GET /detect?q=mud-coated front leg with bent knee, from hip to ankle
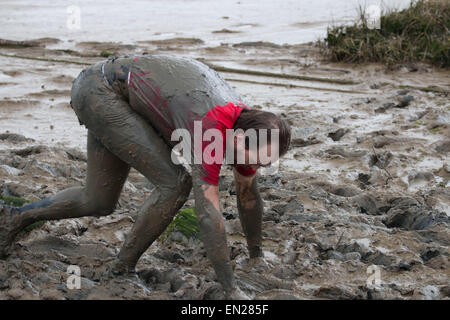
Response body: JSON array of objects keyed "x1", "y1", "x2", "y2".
[{"x1": 67, "y1": 64, "x2": 192, "y2": 271}]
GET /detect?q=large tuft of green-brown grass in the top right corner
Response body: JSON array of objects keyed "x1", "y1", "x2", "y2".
[{"x1": 319, "y1": 0, "x2": 450, "y2": 68}]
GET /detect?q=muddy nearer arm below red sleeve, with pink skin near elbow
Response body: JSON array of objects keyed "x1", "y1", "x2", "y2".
[{"x1": 192, "y1": 168, "x2": 235, "y2": 294}]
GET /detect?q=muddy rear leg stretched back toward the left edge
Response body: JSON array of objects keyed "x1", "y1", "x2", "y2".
[{"x1": 0, "y1": 132, "x2": 130, "y2": 254}]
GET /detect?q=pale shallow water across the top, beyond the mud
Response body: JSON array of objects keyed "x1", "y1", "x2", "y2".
[{"x1": 0, "y1": 0, "x2": 410, "y2": 46}]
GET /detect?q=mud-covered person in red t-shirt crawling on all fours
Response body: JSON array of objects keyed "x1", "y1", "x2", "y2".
[{"x1": 0, "y1": 55, "x2": 290, "y2": 299}]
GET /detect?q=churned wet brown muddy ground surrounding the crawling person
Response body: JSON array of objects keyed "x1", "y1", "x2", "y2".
[{"x1": 0, "y1": 37, "x2": 450, "y2": 299}]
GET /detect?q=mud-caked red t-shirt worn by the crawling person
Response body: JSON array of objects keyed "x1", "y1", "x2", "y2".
[{"x1": 106, "y1": 55, "x2": 255, "y2": 185}]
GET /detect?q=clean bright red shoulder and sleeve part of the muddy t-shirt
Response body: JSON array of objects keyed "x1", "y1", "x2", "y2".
[{"x1": 201, "y1": 102, "x2": 256, "y2": 186}]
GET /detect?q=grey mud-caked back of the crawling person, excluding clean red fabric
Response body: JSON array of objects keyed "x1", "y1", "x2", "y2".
[{"x1": 103, "y1": 55, "x2": 243, "y2": 145}]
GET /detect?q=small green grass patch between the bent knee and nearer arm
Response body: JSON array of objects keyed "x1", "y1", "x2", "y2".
[{"x1": 161, "y1": 208, "x2": 200, "y2": 242}]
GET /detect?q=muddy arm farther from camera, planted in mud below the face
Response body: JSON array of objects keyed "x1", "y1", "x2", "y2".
[{"x1": 233, "y1": 168, "x2": 264, "y2": 258}]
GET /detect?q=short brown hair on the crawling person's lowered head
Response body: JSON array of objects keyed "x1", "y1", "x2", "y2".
[{"x1": 233, "y1": 108, "x2": 291, "y2": 156}]
